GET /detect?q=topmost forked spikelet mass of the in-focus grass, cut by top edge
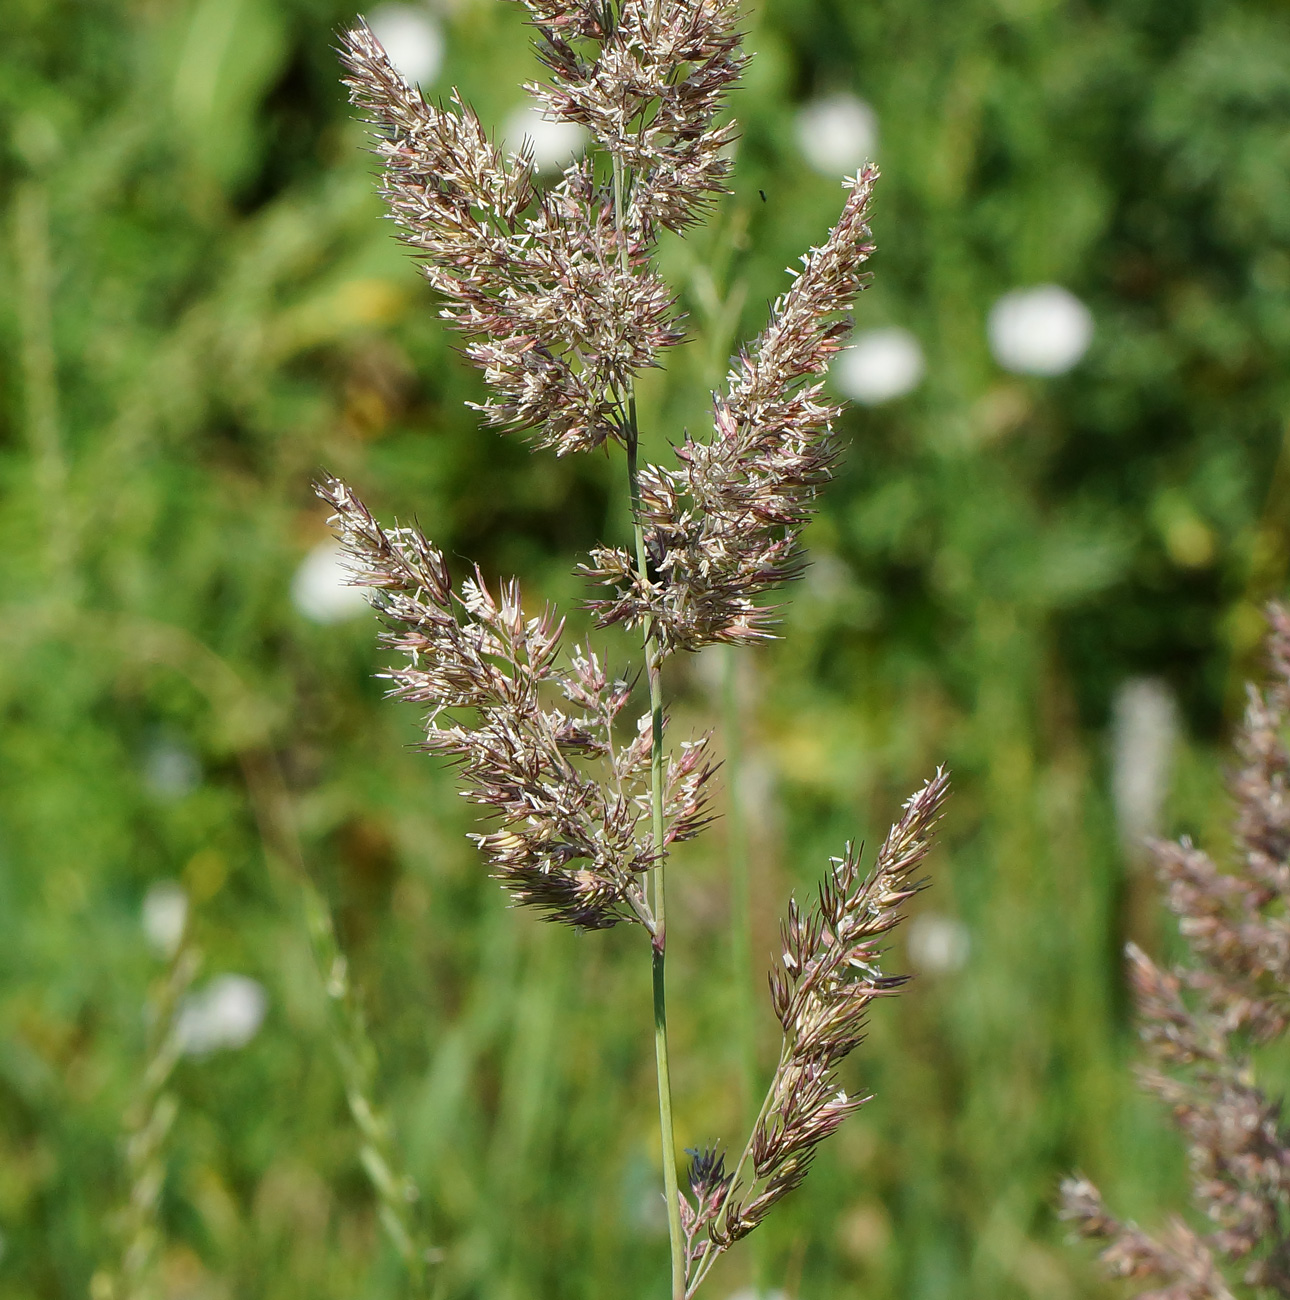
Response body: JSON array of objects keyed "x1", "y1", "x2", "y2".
[{"x1": 341, "y1": 0, "x2": 741, "y2": 455}]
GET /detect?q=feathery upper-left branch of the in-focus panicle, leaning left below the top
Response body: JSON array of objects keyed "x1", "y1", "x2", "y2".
[{"x1": 341, "y1": 22, "x2": 683, "y2": 455}]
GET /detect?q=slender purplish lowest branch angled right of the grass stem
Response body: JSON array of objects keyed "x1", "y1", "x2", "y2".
[{"x1": 684, "y1": 770, "x2": 949, "y2": 1287}]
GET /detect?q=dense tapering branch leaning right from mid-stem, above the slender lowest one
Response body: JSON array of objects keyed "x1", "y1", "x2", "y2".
[{"x1": 584, "y1": 166, "x2": 878, "y2": 650}]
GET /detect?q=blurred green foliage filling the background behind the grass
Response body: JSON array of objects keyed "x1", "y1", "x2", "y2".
[{"x1": 0, "y1": 0, "x2": 1290, "y2": 1300}]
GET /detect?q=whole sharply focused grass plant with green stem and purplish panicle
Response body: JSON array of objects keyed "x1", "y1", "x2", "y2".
[{"x1": 319, "y1": 0, "x2": 947, "y2": 1300}]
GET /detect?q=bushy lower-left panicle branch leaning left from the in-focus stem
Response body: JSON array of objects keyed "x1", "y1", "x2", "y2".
[{"x1": 317, "y1": 478, "x2": 713, "y2": 930}]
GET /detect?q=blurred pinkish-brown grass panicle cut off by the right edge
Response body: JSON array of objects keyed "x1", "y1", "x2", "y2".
[{"x1": 1062, "y1": 606, "x2": 1290, "y2": 1300}]
